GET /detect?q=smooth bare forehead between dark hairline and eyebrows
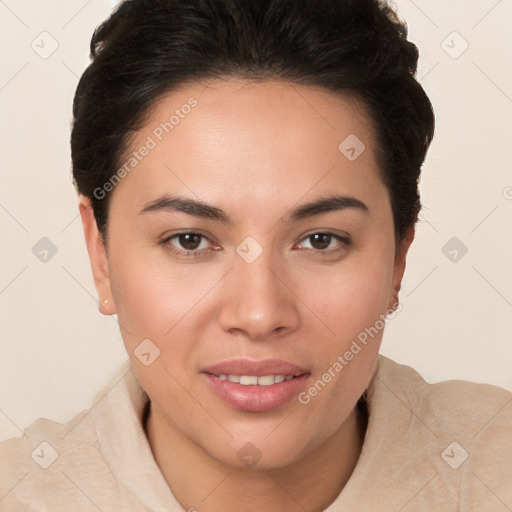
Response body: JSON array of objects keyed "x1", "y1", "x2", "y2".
[{"x1": 114, "y1": 79, "x2": 382, "y2": 212}]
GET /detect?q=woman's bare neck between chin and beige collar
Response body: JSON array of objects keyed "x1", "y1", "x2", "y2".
[{"x1": 145, "y1": 404, "x2": 367, "y2": 512}]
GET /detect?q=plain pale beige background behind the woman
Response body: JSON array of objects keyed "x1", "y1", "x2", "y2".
[{"x1": 0, "y1": 0, "x2": 512, "y2": 439}]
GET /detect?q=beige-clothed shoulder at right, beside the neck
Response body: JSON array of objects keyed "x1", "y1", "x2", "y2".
[{"x1": 363, "y1": 356, "x2": 512, "y2": 511}]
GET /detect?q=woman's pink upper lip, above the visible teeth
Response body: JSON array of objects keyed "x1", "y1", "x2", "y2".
[{"x1": 202, "y1": 359, "x2": 309, "y2": 377}]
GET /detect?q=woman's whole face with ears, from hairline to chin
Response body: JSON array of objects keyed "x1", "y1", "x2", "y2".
[{"x1": 83, "y1": 80, "x2": 408, "y2": 467}]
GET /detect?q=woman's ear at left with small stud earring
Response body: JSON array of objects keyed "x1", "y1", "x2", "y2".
[{"x1": 78, "y1": 195, "x2": 116, "y2": 315}]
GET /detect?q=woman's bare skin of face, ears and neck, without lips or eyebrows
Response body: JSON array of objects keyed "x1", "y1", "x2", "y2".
[{"x1": 80, "y1": 79, "x2": 414, "y2": 512}]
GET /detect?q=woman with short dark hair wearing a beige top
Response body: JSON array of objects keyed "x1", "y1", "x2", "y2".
[{"x1": 0, "y1": 0, "x2": 512, "y2": 512}]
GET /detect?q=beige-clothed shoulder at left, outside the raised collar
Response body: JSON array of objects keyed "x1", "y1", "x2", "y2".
[{"x1": 0, "y1": 365, "x2": 139, "y2": 512}]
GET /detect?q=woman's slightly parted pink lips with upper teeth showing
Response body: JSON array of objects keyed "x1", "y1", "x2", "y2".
[{"x1": 202, "y1": 359, "x2": 310, "y2": 412}]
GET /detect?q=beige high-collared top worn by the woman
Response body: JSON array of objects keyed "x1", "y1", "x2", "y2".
[{"x1": 0, "y1": 356, "x2": 512, "y2": 512}]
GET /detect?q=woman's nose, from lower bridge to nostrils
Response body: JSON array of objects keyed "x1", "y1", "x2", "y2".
[{"x1": 219, "y1": 255, "x2": 300, "y2": 341}]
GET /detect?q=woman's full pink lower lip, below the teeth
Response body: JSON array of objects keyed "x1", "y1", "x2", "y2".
[{"x1": 204, "y1": 373, "x2": 309, "y2": 412}]
